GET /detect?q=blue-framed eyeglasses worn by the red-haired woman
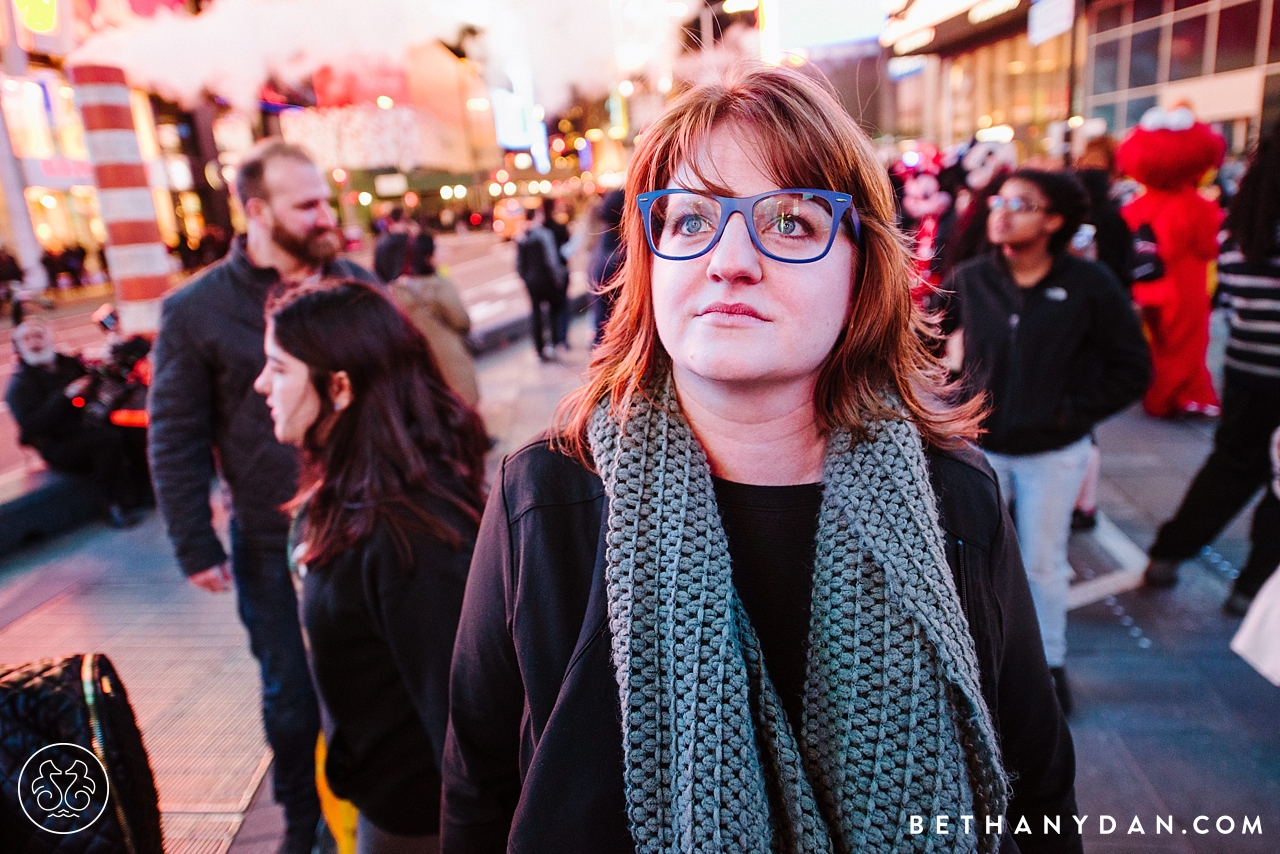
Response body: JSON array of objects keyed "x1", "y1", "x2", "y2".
[{"x1": 636, "y1": 189, "x2": 860, "y2": 264}]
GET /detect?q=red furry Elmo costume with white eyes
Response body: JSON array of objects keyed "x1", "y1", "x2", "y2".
[{"x1": 1116, "y1": 108, "x2": 1225, "y2": 417}]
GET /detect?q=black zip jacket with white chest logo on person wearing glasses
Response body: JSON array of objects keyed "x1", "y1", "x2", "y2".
[{"x1": 942, "y1": 252, "x2": 1151, "y2": 455}]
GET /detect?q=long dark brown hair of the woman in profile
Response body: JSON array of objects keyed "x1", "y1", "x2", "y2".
[{"x1": 268, "y1": 280, "x2": 488, "y2": 565}]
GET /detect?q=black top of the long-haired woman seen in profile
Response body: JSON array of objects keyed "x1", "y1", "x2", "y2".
[{"x1": 302, "y1": 498, "x2": 475, "y2": 836}]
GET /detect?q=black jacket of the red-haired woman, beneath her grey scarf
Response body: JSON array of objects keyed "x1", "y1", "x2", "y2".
[{"x1": 440, "y1": 439, "x2": 1082, "y2": 854}]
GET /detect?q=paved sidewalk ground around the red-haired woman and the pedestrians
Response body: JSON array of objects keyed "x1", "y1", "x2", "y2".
[{"x1": 0, "y1": 313, "x2": 1280, "y2": 854}]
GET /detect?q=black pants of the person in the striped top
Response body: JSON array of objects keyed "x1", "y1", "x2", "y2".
[{"x1": 1151, "y1": 373, "x2": 1280, "y2": 597}]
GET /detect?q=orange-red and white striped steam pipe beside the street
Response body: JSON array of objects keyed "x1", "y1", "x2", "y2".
[{"x1": 70, "y1": 65, "x2": 172, "y2": 335}]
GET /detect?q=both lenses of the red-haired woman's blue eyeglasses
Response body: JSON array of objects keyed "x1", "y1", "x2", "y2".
[{"x1": 649, "y1": 192, "x2": 832, "y2": 261}]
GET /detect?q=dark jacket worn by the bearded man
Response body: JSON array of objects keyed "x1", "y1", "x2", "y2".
[{"x1": 147, "y1": 237, "x2": 376, "y2": 575}]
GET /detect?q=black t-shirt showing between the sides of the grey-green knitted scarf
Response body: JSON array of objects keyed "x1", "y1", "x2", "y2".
[{"x1": 713, "y1": 478, "x2": 822, "y2": 735}]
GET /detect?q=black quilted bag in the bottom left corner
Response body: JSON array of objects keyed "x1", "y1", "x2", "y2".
[{"x1": 0, "y1": 654, "x2": 164, "y2": 854}]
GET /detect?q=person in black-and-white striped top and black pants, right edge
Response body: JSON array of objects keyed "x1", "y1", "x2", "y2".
[{"x1": 1146, "y1": 124, "x2": 1280, "y2": 617}]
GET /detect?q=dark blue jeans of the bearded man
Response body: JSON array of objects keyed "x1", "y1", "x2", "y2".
[{"x1": 232, "y1": 521, "x2": 320, "y2": 853}]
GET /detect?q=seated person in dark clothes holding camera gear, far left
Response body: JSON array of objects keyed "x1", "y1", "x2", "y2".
[{"x1": 5, "y1": 321, "x2": 146, "y2": 528}]
